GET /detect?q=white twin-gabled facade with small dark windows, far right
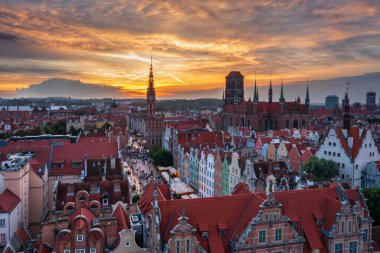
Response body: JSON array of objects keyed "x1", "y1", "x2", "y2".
[{"x1": 316, "y1": 128, "x2": 379, "y2": 187}]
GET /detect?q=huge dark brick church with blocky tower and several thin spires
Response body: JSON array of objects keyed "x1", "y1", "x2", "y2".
[{"x1": 221, "y1": 71, "x2": 310, "y2": 131}]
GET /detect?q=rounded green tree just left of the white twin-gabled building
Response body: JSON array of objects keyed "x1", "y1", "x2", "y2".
[{"x1": 304, "y1": 156, "x2": 339, "y2": 181}]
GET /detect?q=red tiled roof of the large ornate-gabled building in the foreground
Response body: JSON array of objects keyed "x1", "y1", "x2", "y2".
[{"x1": 139, "y1": 184, "x2": 364, "y2": 252}]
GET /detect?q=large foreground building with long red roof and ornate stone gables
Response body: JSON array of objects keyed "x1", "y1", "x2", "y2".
[{"x1": 139, "y1": 183, "x2": 373, "y2": 253}]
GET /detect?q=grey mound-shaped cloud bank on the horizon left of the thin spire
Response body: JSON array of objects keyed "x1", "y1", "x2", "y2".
[{"x1": 16, "y1": 78, "x2": 121, "y2": 98}]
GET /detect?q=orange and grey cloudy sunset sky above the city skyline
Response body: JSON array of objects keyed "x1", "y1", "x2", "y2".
[{"x1": 0, "y1": 0, "x2": 380, "y2": 98}]
